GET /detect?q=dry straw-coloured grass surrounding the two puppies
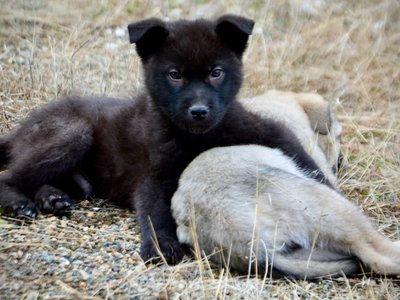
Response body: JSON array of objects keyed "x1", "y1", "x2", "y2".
[{"x1": 0, "y1": 0, "x2": 400, "y2": 299}]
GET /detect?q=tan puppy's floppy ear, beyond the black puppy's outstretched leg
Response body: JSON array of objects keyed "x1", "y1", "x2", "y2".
[{"x1": 297, "y1": 94, "x2": 333, "y2": 135}]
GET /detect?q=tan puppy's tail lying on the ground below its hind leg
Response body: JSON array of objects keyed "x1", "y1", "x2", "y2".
[{"x1": 272, "y1": 250, "x2": 360, "y2": 279}]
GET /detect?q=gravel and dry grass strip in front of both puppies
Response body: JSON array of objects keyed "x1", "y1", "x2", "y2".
[{"x1": 0, "y1": 201, "x2": 400, "y2": 300}]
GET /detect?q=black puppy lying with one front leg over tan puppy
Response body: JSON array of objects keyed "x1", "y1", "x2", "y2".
[{"x1": 0, "y1": 15, "x2": 329, "y2": 262}]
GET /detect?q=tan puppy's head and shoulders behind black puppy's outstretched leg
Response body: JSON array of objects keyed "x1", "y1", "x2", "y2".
[{"x1": 241, "y1": 90, "x2": 342, "y2": 183}]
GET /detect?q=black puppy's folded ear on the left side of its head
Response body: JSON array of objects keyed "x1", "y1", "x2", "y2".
[{"x1": 128, "y1": 18, "x2": 169, "y2": 61}]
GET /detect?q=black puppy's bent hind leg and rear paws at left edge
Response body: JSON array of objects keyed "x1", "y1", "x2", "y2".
[{"x1": 0, "y1": 116, "x2": 93, "y2": 217}]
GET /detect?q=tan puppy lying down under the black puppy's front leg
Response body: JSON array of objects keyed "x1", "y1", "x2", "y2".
[{"x1": 172, "y1": 91, "x2": 400, "y2": 278}]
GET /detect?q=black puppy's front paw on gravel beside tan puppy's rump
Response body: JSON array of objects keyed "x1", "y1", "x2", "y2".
[{"x1": 140, "y1": 235, "x2": 183, "y2": 265}]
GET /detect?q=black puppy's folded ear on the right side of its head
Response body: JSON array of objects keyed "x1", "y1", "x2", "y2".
[{"x1": 215, "y1": 15, "x2": 254, "y2": 58}]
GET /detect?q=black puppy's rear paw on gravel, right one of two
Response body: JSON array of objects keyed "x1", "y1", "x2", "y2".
[{"x1": 35, "y1": 185, "x2": 74, "y2": 215}]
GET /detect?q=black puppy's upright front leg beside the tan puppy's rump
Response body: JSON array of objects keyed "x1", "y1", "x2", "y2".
[{"x1": 135, "y1": 177, "x2": 183, "y2": 264}]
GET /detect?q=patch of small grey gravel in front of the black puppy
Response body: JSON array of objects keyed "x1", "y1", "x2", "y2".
[{"x1": 0, "y1": 201, "x2": 219, "y2": 299}]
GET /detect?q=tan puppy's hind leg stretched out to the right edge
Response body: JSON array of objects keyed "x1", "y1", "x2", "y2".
[{"x1": 315, "y1": 185, "x2": 400, "y2": 275}]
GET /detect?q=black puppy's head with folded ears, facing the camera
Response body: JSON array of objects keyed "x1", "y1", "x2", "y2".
[{"x1": 128, "y1": 15, "x2": 254, "y2": 134}]
